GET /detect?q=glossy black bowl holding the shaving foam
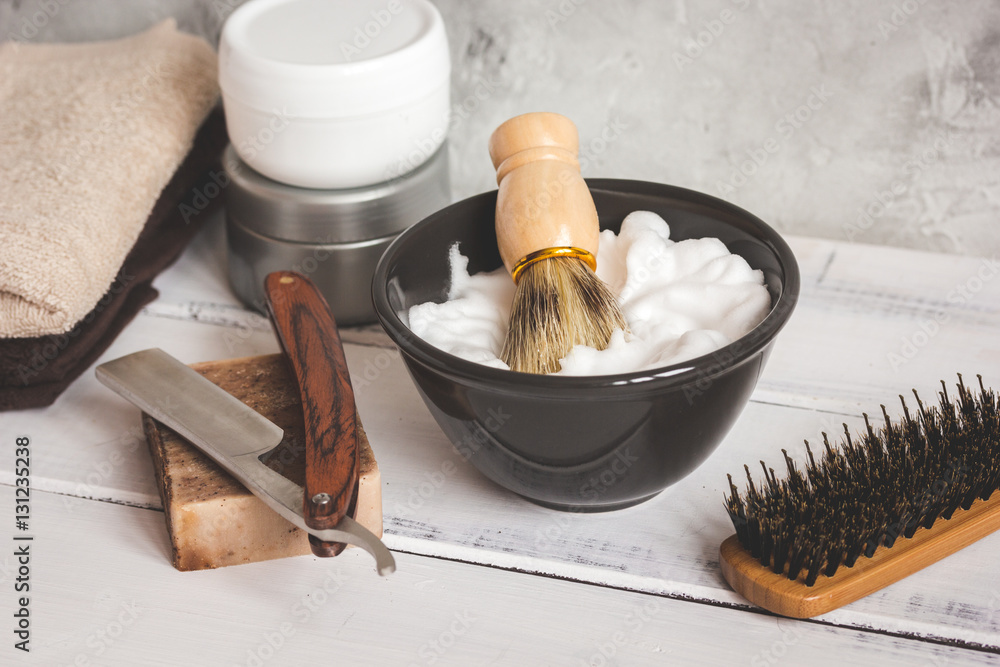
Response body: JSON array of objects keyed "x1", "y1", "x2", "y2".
[{"x1": 372, "y1": 179, "x2": 799, "y2": 511}]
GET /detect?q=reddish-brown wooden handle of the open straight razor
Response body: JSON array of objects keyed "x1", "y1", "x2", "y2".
[{"x1": 264, "y1": 271, "x2": 358, "y2": 556}]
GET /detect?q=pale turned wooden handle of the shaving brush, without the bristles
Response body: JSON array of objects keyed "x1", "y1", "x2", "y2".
[{"x1": 489, "y1": 113, "x2": 600, "y2": 271}]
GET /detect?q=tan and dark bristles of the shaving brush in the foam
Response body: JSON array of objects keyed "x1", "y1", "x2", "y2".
[{"x1": 500, "y1": 257, "x2": 628, "y2": 373}]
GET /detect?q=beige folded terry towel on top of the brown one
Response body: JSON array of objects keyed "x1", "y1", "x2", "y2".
[{"x1": 0, "y1": 20, "x2": 218, "y2": 338}]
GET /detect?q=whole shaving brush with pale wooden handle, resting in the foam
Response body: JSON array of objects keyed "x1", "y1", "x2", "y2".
[{"x1": 489, "y1": 113, "x2": 628, "y2": 373}]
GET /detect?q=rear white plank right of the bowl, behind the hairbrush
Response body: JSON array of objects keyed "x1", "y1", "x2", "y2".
[{"x1": 755, "y1": 238, "x2": 1000, "y2": 414}]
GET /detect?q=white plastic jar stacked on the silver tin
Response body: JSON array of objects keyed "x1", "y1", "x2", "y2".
[{"x1": 219, "y1": 0, "x2": 451, "y2": 189}]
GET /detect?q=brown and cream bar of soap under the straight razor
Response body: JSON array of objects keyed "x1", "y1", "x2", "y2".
[{"x1": 143, "y1": 354, "x2": 382, "y2": 571}]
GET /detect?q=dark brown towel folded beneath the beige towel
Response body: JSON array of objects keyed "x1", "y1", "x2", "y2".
[{"x1": 0, "y1": 109, "x2": 227, "y2": 411}]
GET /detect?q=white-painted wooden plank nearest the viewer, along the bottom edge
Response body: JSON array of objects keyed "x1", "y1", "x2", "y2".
[{"x1": 0, "y1": 487, "x2": 995, "y2": 667}]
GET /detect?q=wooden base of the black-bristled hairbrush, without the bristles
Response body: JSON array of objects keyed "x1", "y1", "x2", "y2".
[{"x1": 719, "y1": 491, "x2": 1000, "y2": 618}]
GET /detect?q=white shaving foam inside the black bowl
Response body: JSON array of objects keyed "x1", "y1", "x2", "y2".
[{"x1": 408, "y1": 211, "x2": 771, "y2": 375}]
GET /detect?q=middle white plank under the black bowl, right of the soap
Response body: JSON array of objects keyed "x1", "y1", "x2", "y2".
[{"x1": 350, "y1": 344, "x2": 1000, "y2": 647}]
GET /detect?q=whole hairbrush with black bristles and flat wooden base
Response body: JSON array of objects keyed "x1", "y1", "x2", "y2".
[{"x1": 720, "y1": 376, "x2": 1000, "y2": 618}]
